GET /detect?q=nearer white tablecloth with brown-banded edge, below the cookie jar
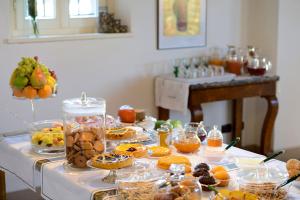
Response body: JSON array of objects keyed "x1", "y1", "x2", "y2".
[{"x1": 42, "y1": 146, "x2": 300, "y2": 200}]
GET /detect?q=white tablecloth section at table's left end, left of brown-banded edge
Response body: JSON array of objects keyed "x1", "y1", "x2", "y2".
[{"x1": 0, "y1": 134, "x2": 62, "y2": 191}]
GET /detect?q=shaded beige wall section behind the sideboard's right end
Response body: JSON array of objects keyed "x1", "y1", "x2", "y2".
[{"x1": 241, "y1": 0, "x2": 278, "y2": 145}]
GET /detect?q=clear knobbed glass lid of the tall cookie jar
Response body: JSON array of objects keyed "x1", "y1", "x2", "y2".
[{"x1": 63, "y1": 92, "x2": 106, "y2": 116}]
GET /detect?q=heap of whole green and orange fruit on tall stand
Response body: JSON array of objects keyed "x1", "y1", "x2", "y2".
[{"x1": 9, "y1": 57, "x2": 57, "y2": 99}]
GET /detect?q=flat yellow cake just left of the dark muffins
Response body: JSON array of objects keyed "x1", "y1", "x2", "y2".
[{"x1": 157, "y1": 156, "x2": 191, "y2": 173}]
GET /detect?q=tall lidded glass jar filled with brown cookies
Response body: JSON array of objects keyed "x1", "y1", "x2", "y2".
[{"x1": 63, "y1": 92, "x2": 106, "y2": 168}]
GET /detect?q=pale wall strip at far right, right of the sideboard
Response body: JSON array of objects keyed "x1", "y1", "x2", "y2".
[{"x1": 274, "y1": 0, "x2": 300, "y2": 149}]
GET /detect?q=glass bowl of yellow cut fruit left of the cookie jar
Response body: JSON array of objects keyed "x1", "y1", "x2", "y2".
[{"x1": 31, "y1": 120, "x2": 64, "y2": 154}]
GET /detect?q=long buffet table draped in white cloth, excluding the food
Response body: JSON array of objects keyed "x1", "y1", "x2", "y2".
[{"x1": 0, "y1": 131, "x2": 300, "y2": 200}]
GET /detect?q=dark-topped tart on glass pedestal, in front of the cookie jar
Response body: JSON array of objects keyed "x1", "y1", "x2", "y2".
[{"x1": 91, "y1": 153, "x2": 133, "y2": 170}]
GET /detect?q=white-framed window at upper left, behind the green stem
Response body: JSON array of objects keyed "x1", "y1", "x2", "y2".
[{"x1": 12, "y1": 0, "x2": 98, "y2": 36}]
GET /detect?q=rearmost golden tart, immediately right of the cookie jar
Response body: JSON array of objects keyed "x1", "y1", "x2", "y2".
[{"x1": 105, "y1": 128, "x2": 136, "y2": 140}]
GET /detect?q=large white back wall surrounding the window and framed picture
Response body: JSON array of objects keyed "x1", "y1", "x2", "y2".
[{"x1": 0, "y1": 0, "x2": 243, "y2": 193}]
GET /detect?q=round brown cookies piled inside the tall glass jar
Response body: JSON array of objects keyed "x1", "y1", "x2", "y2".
[{"x1": 65, "y1": 126, "x2": 105, "y2": 168}]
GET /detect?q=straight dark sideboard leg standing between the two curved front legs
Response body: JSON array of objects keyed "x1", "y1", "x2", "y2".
[{"x1": 232, "y1": 99, "x2": 243, "y2": 148}]
